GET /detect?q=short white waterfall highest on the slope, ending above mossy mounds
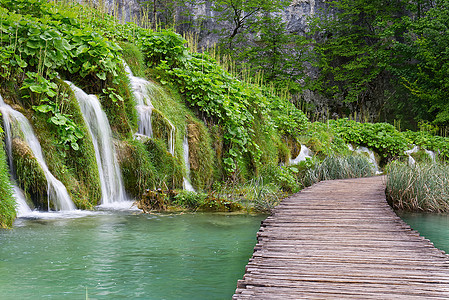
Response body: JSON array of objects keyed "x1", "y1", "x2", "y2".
[{"x1": 124, "y1": 63, "x2": 154, "y2": 137}]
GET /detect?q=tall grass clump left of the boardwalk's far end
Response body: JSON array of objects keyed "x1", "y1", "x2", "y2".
[{"x1": 303, "y1": 155, "x2": 375, "y2": 186}]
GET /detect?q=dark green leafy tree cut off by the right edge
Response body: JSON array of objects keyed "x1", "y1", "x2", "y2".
[{"x1": 394, "y1": 0, "x2": 449, "y2": 125}]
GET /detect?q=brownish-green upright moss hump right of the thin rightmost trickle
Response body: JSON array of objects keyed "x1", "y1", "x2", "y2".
[{"x1": 187, "y1": 116, "x2": 215, "y2": 190}]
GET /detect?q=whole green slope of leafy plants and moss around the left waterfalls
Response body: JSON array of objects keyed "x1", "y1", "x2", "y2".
[{"x1": 0, "y1": 0, "x2": 307, "y2": 218}]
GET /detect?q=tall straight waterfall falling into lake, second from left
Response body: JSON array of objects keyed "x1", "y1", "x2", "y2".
[{"x1": 66, "y1": 81, "x2": 127, "y2": 205}]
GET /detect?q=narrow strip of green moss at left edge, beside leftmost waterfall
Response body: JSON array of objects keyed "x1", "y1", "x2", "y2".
[{"x1": 0, "y1": 136, "x2": 16, "y2": 228}]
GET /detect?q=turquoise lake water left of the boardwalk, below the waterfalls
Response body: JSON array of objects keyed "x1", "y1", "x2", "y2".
[{"x1": 0, "y1": 212, "x2": 265, "y2": 300}]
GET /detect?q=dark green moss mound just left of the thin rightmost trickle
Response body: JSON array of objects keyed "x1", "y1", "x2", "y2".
[{"x1": 145, "y1": 138, "x2": 183, "y2": 189}]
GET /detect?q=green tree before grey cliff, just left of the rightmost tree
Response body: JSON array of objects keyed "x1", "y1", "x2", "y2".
[{"x1": 311, "y1": 0, "x2": 407, "y2": 117}]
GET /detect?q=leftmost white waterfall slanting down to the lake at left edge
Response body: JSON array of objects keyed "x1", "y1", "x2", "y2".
[{"x1": 0, "y1": 96, "x2": 76, "y2": 210}]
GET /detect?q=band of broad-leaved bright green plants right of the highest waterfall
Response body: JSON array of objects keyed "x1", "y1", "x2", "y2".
[{"x1": 141, "y1": 28, "x2": 306, "y2": 174}]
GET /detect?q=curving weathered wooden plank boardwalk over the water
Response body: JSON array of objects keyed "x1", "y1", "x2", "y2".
[{"x1": 233, "y1": 177, "x2": 449, "y2": 299}]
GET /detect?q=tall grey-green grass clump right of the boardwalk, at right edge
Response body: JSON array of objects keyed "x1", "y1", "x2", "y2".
[{"x1": 386, "y1": 161, "x2": 449, "y2": 212}]
